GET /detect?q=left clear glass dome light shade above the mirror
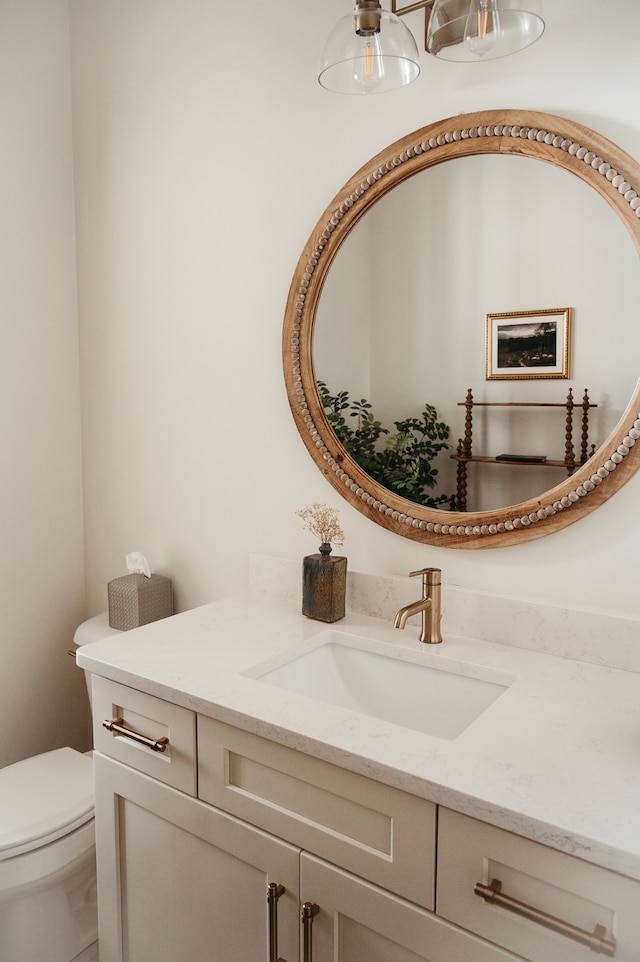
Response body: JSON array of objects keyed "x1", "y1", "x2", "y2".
[{"x1": 318, "y1": 0, "x2": 420, "y2": 94}]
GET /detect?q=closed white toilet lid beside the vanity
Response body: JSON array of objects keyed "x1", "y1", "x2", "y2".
[{"x1": 0, "y1": 748, "x2": 94, "y2": 859}]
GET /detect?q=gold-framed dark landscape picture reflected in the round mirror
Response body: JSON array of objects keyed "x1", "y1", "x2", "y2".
[{"x1": 487, "y1": 307, "x2": 571, "y2": 381}]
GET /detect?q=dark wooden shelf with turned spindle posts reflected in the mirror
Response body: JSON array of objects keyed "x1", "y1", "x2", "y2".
[{"x1": 451, "y1": 388, "x2": 598, "y2": 511}]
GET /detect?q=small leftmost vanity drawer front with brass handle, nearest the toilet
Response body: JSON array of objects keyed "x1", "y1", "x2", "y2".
[{"x1": 91, "y1": 675, "x2": 197, "y2": 795}]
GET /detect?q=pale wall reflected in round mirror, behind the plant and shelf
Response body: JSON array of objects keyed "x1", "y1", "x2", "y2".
[{"x1": 313, "y1": 154, "x2": 638, "y2": 511}]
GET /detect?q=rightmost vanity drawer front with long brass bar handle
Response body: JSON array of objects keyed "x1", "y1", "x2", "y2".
[{"x1": 436, "y1": 809, "x2": 640, "y2": 962}]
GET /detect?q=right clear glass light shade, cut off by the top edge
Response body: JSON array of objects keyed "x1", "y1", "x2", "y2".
[{"x1": 427, "y1": 0, "x2": 544, "y2": 63}]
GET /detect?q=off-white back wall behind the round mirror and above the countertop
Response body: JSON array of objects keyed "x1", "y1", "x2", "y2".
[{"x1": 70, "y1": 0, "x2": 640, "y2": 615}]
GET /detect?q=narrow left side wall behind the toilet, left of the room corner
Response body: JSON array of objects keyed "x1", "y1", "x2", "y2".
[{"x1": 0, "y1": 0, "x2": 88, "y2": 767}]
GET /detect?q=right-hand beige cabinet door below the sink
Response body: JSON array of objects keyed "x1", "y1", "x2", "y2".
[{"x1": 300, "y1": 852, "x2": 518, "y2": 962}]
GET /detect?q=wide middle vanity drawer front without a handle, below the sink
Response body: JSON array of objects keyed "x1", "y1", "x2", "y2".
[{"x1": 198, "y1": 716, "x2": 436, "y2": 909}]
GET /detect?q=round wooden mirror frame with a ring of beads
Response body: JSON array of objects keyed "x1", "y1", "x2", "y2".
[{"x1": 283, "y1": 110, "x2": 640, "y2": 548}]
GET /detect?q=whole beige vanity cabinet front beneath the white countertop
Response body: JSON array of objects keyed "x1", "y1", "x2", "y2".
[{"x1": 93, "y1": 678, "x2": 640, "y2": 962}]
